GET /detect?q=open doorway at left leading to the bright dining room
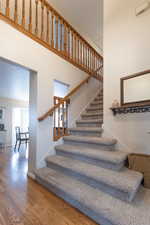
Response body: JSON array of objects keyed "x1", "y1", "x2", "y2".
[{"x1": 0, "y1": 58, "x2": 37, "y2": 175}]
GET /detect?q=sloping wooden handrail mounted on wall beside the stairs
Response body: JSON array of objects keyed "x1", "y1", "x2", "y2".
[{"x1": 38, "y1": 67, "x2": 102, "y2": 122}]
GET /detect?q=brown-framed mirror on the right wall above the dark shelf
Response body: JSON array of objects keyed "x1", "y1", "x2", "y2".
[{"x1": 121, "y1": 70, "x2": 150, "y2": 106}]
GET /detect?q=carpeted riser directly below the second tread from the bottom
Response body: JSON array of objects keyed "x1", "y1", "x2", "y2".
[{"x1": 46, "y1": 162, "x2": 129, "y2": 201}]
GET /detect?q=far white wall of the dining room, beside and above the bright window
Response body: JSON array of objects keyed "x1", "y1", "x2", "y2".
[{"x1": 0, "y1": 97, "x2": 28, "y2": 146}]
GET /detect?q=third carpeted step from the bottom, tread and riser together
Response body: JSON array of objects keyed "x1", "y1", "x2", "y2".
[{"x1": 55, "y1": 144, "x2": 127, "y2": 170}]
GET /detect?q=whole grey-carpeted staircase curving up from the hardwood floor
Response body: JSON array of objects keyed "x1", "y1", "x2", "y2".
[{"x1": 35, "y1": 92, "x2": 146, "y2": 225}]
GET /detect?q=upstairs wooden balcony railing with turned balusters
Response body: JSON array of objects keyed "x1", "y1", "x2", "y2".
[{"x1": 0, "y1": 0, "x2": 103, "y2": 78}]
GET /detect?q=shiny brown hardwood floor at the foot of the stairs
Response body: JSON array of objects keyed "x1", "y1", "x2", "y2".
[{"x1": 0, "y1": 148, "x2": 96, "y2": 225}]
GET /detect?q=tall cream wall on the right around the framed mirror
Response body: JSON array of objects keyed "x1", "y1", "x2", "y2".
[{"x1": 104, "y1": 0, "x2": 150, "y2": 154}]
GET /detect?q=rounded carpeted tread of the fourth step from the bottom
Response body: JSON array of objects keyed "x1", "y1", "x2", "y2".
[{"x1": 63, "y1": 135, "x2": 117, "y2": 146}]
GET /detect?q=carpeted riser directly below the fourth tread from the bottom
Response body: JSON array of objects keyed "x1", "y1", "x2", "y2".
[{"x1": 64, "y1": 140, "x2": 115, "y2": 151}]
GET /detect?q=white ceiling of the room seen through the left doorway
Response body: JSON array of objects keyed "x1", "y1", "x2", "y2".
[{"x1": 0, "y1": 59, "x2": 29, "y2": 101}]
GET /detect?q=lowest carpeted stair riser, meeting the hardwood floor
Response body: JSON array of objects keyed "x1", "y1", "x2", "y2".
[{"x1": 36, "y1": 176, "x2": 112, "y2": 225}]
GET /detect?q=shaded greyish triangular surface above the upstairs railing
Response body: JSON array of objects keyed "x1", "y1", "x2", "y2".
[{"x1": 48, "y1": 0, "x2": 103, "y2": 49}]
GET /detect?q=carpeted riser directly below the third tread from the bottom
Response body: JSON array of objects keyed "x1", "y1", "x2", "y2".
[{"x1": 56, "y1": 149, "x2": 124, "y2": 171}]
